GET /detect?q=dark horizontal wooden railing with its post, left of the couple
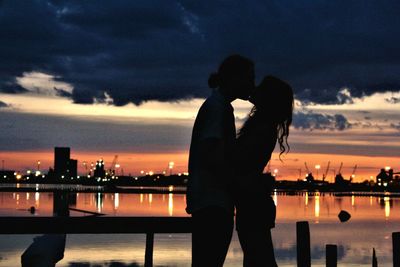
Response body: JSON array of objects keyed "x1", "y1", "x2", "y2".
[{"x1": 0, "y1": 216, "x2": 192, "y2": 267}]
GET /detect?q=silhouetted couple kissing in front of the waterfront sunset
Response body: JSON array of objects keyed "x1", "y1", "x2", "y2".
[{"x1": 186, "y1": 55, "x2": 293, "y2": 267}]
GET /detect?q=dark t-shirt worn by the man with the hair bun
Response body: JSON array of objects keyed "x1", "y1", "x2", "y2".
[{"x1": 186, "y1": 90, "x2": 236, "y2": 214}]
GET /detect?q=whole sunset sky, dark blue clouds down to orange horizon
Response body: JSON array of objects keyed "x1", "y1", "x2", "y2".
[{"x1": 0, "y1": 0, "x2": 400, "y2": 181}]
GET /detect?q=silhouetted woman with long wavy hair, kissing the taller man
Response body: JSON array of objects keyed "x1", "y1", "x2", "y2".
[{"x1": 234, "y1": 76, "x2": 293, "y2": 267}]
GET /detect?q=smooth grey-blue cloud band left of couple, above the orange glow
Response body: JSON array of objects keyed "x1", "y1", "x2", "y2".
[{"x1": 0, "y1": 109, "x2": 192, "y2": 152}]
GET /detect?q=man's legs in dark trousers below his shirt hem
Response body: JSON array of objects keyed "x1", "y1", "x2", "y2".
[{"x1": 192, "y1": 207, "x2": 233, "y2": 267}]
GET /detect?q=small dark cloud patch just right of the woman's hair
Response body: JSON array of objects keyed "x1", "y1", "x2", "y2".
[{"x1": 292, "y1": 112, "x2": 352, "y2": 131}]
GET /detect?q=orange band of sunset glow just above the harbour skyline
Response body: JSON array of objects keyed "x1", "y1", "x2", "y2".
[{"x1": 0, "y1": 149, "x2": 399, "y2": 182}]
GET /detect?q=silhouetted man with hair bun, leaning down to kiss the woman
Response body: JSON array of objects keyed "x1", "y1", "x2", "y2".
[{"x1": 186, "y1": 55, "x2": 254, "y2": 267}]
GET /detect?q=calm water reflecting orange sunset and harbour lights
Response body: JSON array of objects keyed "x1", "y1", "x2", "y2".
[{"x1": 0, "y1": 192, "x2": 400, "y2": 267}]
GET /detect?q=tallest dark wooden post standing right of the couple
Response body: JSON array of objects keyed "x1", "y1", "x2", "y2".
[{"x1": 296, "y1": 221, "x2": 311, "y2": 267}]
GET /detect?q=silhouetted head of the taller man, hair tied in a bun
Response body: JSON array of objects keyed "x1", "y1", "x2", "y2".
[{"x1": 208, "y1": 55, "x2": 255, "y2": 100}]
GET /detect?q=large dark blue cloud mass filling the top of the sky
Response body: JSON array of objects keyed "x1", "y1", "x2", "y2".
[{"x1": 0, "y1": 0, "x2": 400, "y2": 105}]
